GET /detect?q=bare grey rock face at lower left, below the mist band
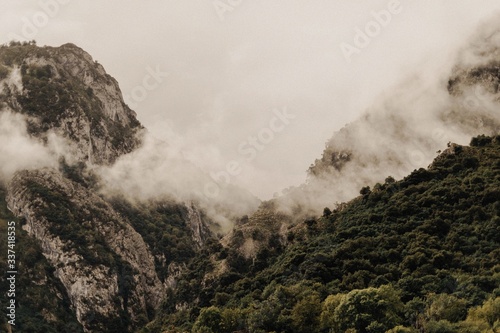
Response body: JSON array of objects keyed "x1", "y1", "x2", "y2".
[{"x1": 7, "y1": 169, "x2": 164, "y2": 332}]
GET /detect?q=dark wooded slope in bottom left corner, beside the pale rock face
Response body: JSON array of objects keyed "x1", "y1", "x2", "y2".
[{"x1": 0, "y1": 186, "x2": 83, "y2": 333}]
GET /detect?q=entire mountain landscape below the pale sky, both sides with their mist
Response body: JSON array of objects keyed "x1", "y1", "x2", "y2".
[{"x1": 0, "y1": 24, "x2": 500, "y2": 333}]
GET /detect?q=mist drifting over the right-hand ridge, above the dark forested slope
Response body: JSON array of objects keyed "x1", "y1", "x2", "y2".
[{"x1": 276, "y1": 21, "x2": 500, "y2": 215}]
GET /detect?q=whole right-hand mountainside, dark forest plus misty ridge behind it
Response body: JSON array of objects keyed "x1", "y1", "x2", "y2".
[{"x1": 148, "y1": 24, "x2": 500, "y2": 332}]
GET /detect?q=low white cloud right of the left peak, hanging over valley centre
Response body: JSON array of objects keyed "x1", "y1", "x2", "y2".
[{"x1": 95, "y1": 133, "x2": 260, "y2": 232}]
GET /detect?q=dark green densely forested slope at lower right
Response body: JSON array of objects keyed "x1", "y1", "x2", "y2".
[{"x1": 152, "y1": 136, "x2": 500, "y2": 333}]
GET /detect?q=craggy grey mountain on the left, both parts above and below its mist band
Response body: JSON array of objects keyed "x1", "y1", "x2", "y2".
[{"x1": 0, "y1": 42, "x2": 218, "y2": 332}]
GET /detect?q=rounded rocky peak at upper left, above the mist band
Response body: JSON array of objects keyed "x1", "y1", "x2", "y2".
[{"x1": 0, "y1": 44, "x2": 142, "y2": 164}]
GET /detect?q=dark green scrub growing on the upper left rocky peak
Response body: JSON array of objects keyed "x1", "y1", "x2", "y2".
[{"x1": 0, "y1": 42, "x2": 140, "y2": 151}]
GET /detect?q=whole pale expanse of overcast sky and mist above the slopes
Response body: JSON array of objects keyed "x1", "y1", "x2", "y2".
[{"x1": 0, "y1": 0, "x2": 500, "y2": 229}]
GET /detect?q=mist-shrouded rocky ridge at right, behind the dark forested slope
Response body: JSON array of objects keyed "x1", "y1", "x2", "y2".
[{"x1": 207, "y1": 25, "x2": 500, "y2": 278}]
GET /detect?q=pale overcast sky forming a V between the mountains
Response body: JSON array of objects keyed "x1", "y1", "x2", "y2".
[{"x1": 0, "y1": 0, "x2": 500, "y2": 199}]
